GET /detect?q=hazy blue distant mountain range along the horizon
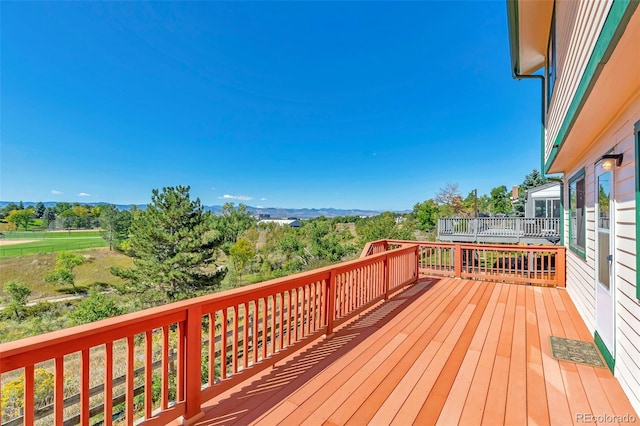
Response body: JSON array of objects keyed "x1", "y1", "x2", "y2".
[{"x1": 0, "y1": 201, "x2": 381, "y2": 219}]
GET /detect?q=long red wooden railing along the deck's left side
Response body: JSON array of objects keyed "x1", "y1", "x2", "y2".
[{"x1": 0, "y1": 242, "x2": 422, "y2": 425}]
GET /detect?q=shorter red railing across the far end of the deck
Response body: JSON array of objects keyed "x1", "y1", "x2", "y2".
[{"x1": 361, "y1": 240, "x2": 566, "y2": 287}]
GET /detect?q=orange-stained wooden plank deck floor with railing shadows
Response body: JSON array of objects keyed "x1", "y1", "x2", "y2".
[{"x1": 189, "y1": 279, "x2": 638, "y2": 426}]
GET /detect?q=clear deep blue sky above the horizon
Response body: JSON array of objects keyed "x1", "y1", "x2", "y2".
[{"x1": 0, "y1": 1, "x2": 540, "y2": 210}]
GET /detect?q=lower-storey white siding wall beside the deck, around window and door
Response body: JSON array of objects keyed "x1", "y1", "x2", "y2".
[{"x1": 563, "y1": 92, "x2": 640, "y2": 412}]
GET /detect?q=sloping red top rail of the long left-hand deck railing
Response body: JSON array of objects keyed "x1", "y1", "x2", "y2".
[{"x1": 0, "y1": 242, "x2": 415, "y2": 364}]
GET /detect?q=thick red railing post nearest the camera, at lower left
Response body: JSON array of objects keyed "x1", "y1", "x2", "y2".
[{"x1": 182, "y1": 305, "x2": 204, "y2": 425}]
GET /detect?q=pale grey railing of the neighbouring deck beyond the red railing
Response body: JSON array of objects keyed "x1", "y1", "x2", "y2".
[{"x1": 438, "y1": 217, "x2": 560, "y2": 244}]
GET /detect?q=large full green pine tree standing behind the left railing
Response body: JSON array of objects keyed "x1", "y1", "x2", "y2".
[{"x1": 111, "y1": 186, "x2": 225, "y2": 305}]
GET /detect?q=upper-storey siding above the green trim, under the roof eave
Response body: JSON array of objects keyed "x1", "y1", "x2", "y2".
[{"x1": 545, "y1": 0, "x2": 613, "y2": 160}]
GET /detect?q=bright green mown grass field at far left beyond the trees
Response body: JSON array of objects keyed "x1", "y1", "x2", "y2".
[{"x1": 0, "y1": 231, "x2": 107, "y2": 258}]
